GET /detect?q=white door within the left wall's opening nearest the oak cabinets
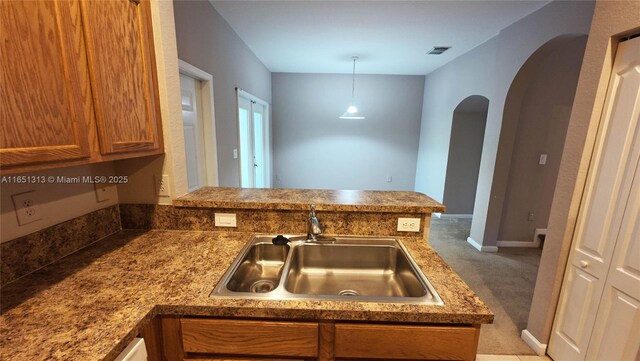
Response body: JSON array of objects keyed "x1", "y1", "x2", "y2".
[{"x1": 180, "y1": 74, "x2": 206, "y2": 192}]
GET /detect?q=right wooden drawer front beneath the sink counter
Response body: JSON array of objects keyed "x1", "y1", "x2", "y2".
[{"x1": 335, "y1": 323, "x2": 480, "y2": 360}]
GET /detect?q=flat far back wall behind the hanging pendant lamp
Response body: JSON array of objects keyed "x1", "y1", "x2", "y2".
[{"x1": 272, "y1": 73, "x2": 424, "y2": 190}]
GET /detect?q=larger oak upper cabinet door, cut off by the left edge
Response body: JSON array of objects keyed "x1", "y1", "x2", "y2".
[{"x1": 0, "y1": 1, "x2": 93, "y2": 166}]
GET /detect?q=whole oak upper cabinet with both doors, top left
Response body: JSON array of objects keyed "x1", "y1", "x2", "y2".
[{"x1": 0, "y1": 0, "x2": 163, "y2": 172}]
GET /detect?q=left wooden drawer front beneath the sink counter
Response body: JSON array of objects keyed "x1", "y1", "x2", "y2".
[{"x1": 181, "y1": 318, "x2": 318, "y2": 357}]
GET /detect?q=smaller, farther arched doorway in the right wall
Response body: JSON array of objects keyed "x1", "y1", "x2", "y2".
[{"x1": 443, "y1": 95, "x2": 489, "y2": 218}]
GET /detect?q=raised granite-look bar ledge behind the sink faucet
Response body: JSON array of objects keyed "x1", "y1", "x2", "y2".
[{"x1": 173, "y1": 187, "x2": 445, "y2": 213}]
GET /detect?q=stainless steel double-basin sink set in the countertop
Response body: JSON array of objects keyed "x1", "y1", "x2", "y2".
[{"x1": 211, "y1": 235, "x2": 443, "y2": 305}]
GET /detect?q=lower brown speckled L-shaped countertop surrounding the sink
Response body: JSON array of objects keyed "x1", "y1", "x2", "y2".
[{"x1": 0, "y1": 231, "x2": 493, "y2": 361}]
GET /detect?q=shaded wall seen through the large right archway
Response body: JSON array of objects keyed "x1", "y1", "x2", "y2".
[{"x1": 498, "y1": 36, "x2": 586, "y2": 242}]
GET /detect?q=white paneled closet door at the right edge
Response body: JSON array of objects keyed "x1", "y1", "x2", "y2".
[{"x1": 549, "y1": 38, "x2": 640, "y2": 361}]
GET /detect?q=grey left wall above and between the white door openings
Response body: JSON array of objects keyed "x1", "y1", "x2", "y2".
[{"x1": 174, "y1": 0, "x2": 271, "y2": 187}]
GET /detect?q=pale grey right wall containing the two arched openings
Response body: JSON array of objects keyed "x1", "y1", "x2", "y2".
[{"x1": 415, "y1": 1, "x2": 594, "y2": 246}]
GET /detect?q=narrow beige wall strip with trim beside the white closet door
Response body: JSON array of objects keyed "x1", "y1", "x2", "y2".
[{"x1": 527, "y1": 0, "x2": 640, "y2": 343}]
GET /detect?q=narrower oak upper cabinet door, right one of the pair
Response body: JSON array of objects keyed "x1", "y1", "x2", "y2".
[{"x1": 81, "y1": 0, "x2": 162, "y2": 154}]
